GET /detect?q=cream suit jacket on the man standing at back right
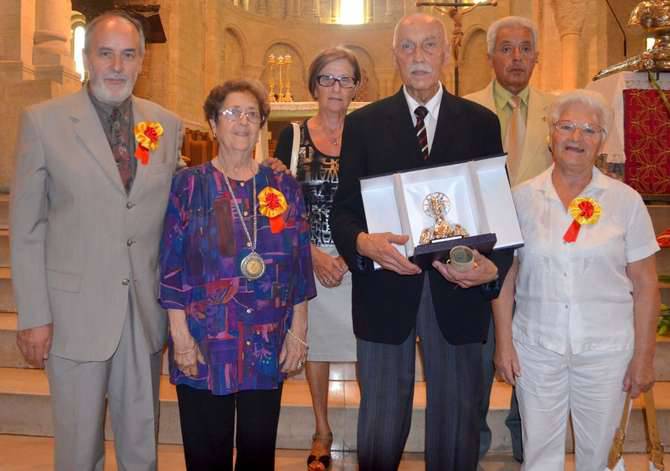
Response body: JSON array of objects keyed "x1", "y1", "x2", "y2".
[{"x1": 464, "y1": 82, "x2": 555, "y2": 185}]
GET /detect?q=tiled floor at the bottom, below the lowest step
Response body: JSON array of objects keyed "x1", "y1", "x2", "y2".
[{"x1": 0, "y1": 435, "x2": 670, "y2": 471}]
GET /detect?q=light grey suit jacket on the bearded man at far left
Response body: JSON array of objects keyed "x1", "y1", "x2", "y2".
[{"x1": 10, "y1": 89, "x2": 182, "y2": 361}]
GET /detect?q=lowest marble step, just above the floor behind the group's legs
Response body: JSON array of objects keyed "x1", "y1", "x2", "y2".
[{"x1": 0, "y1": 368, "x2": 670, "y2": 453}]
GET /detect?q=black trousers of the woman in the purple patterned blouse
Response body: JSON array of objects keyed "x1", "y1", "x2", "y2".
[{"x1": 177, "y1": 385, "x2": 282, "y2": 471}]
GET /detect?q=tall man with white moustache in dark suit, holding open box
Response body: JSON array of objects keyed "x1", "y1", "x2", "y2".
[{"x1": 333, "y1": 14, "x2": 512, "y2": 471}]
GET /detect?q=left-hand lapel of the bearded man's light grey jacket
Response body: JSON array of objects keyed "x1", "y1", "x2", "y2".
[{"x1": 70, "y1": 88, "x2": 126, "y2": 194}]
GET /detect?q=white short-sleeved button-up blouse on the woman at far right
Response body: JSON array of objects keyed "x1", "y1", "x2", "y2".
[{"x1": 513, "y1": 165, "x2": 659, "y2": 354}]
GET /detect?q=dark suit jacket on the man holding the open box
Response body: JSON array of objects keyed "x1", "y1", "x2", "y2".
[{"x1": 332, "y1": 89, "x2": 512, "y2": 344}]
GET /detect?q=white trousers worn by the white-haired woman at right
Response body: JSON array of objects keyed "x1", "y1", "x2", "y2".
[{"x1": 514, "y1": 341, "x2": 633, "y2": 471}]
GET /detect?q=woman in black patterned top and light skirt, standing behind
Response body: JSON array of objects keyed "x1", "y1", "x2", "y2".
[{"x1": 275, "y1": 48, "x2": 361, "y2": 471}]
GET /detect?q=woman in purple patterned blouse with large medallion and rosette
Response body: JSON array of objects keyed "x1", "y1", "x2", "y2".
[{"x1": 160, "y1": 80, "x2": 316, "y2": 471}]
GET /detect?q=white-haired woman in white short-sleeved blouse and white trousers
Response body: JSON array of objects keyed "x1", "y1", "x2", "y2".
[{"x1": 494, "y1": 90, "x2": 660, "y2": 471}]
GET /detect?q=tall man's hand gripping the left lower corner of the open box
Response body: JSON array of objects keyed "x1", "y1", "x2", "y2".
[{"x1": 356, "y1": 232, "x2": 421, "y2": 275}]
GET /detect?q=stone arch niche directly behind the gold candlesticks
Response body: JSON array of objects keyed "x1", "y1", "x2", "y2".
[{"x1": 260, "y1": 40, "x2": 312, "y2": 101}]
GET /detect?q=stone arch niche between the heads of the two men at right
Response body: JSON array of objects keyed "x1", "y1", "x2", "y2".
[{"x1": 458, "y1": 26, "x2": 492, "y2": 96}]
